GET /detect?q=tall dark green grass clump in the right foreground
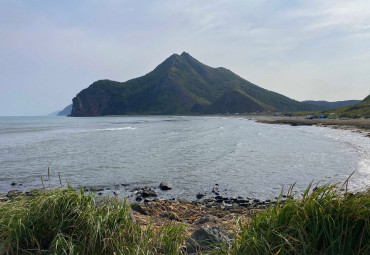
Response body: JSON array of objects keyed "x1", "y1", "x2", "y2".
[{"x1": 225, "y1": 185, "x2": 370, "y2": 255}]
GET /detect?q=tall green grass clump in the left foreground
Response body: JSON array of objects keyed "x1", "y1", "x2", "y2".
[{"x1": 0, "y1": 187, "x2": 185, "y2": 254}]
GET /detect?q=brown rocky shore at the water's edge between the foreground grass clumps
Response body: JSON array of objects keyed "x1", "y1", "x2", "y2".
[{"x1": 0, "y1": 182, "x2": 284, "y2": 254}]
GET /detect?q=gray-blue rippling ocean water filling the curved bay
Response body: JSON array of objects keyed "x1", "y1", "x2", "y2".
[{"x1": 0, "y1": 116, "x2": 370, "y2": 199}]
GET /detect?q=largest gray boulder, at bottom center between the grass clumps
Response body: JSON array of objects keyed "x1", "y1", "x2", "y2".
[{"x1": 186, "y1": 227, "x2": 230, "y2": 253}]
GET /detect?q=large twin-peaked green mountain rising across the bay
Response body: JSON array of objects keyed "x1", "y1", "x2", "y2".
[{"x1": 71, "y1": 52, "x2": 320, "y2": 116}]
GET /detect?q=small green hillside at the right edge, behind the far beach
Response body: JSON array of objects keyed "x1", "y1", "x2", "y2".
[{"x1": 326, "y1": 95, "x2": 370, "y2": 118}]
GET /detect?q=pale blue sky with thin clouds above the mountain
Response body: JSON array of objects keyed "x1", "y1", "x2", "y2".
[{"x1": 0, "y1": 0, "x2": 370, "y2": 116}]
